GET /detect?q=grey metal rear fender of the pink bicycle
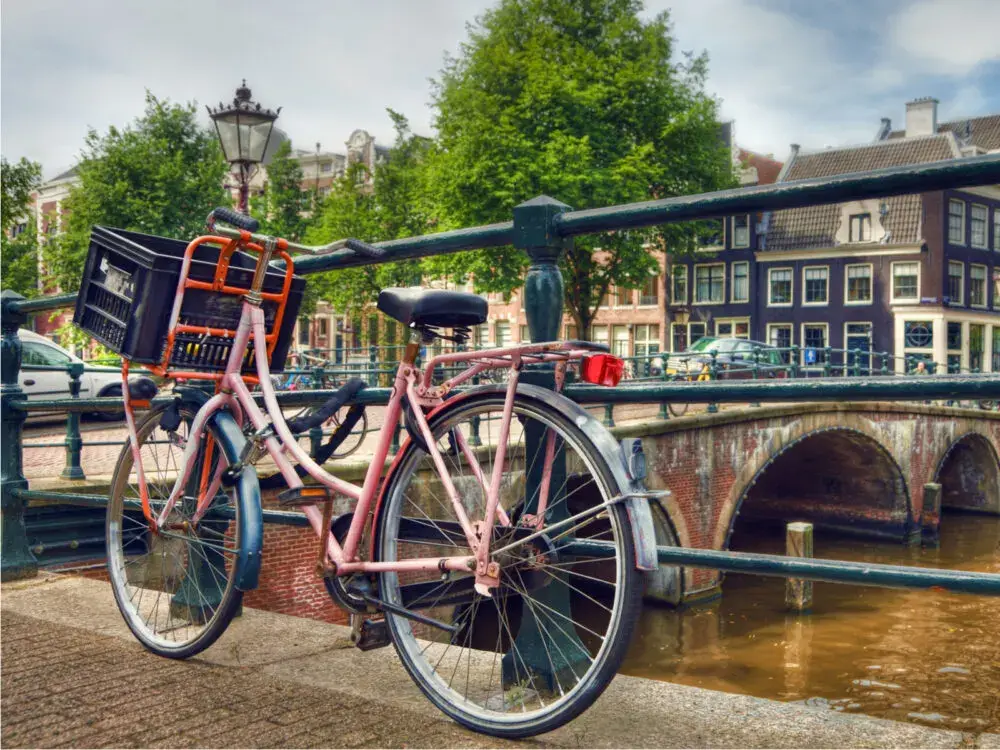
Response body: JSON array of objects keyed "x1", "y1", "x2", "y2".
[{"x1": 372, "y1": 383, "x2": 659, "y2": 570}]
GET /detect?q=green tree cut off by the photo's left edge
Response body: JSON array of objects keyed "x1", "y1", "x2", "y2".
[{"x1": 0, "y1": 157, "x2": 42, "y2": 297}]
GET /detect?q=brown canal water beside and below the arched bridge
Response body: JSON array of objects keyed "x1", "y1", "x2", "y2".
[{"x1": 622, "y1": 512, "x2": 1000, "y2": 732}]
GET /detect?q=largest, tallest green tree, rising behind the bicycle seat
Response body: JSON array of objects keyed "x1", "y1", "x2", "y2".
[{"x1": 429, "y1": 0, "x2": 733, "y2": 332}]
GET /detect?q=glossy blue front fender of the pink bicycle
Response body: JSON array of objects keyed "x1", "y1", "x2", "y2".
[{"x1": 176, "y1": 388, "x2": 264, "y2": 591}]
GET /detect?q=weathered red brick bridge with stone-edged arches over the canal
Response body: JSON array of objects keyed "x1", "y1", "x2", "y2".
[{"x1": 616, "y1": 403, "x2": 1000, "y2": 602}]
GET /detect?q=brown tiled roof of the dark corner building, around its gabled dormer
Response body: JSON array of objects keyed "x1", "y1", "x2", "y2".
[{"x1": 764, "y1": 134, "x2": 958, "y2": 250}]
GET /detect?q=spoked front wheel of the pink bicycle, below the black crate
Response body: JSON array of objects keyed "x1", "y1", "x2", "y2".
[{"x1": 105, "y1": 405, "x2": 243, "y2": 659}]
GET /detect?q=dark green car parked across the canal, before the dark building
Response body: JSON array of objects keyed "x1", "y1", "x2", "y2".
[{"x1": 667, "y1": 336, "x2": 787, "y2": 380}]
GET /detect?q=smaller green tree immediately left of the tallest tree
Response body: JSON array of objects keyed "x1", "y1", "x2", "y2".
[{"x1": 306, "y1": 109, "x2": 431, "y2": 312}]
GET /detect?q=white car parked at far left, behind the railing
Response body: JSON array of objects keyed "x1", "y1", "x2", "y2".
[{"x1": 17, "y1": 329, "x2": 122, "y2": 419}]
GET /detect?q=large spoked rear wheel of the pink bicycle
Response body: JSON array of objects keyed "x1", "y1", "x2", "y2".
[{"x1": 374, "y1": 389, "x2": 641, "y2": 737}]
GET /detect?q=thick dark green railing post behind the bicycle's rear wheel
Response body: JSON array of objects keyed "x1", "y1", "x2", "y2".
[{"x1": 502, "y1": 196, "x2": 589, "y2": 689}]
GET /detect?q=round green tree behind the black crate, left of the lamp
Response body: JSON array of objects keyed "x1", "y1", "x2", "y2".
[{"x1": 43, "y1": 92, "x2": 231, "y2": 292}]
